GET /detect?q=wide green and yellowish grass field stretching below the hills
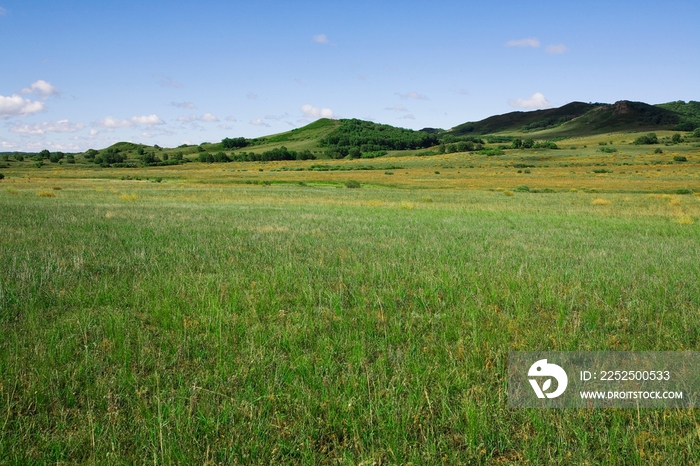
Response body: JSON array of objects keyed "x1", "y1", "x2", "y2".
[{"x1": 0, "y1": 144, "x2": 700, "y2": 465}]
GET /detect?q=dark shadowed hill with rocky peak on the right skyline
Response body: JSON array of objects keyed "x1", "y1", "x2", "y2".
[{"x1": 450, "y1": 100, "x2": 700, "y2": 138}]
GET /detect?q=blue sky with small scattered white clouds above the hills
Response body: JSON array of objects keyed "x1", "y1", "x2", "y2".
[{"x1": 0, "y1": 0, "x2": 700, "y2": 152}]
